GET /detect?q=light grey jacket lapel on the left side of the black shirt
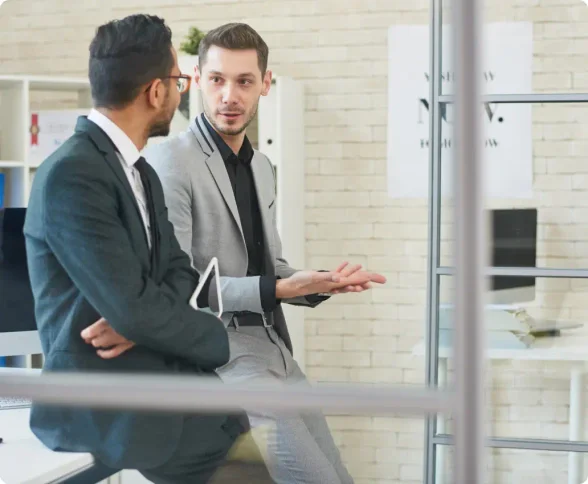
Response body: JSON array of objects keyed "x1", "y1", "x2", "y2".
[{"x1": 190, "y1": 114, "x2": 245, "y2": 243}]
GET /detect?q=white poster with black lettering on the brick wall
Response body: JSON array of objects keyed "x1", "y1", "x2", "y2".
[{"x1": 387, "y1": 22, "x2": 533, "y2": 199}]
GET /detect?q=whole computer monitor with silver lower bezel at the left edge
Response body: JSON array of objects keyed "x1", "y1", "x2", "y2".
[{"x1": 0, "y1": 208, "x2": 42, "y2": 356}]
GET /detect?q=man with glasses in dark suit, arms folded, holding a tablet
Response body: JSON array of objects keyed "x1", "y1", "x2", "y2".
[{"x1": 25, "y1": 15, "x2": 246, "y2": 484}]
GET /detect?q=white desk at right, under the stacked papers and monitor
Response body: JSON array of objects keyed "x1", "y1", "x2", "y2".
[{"x1": 413, "y1": 330, "x2": 588, "y2": 484}]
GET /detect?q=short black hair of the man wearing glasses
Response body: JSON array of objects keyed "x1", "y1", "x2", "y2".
[{"x1": 89, "y1": 15, "x2": 174, "y2": 109}]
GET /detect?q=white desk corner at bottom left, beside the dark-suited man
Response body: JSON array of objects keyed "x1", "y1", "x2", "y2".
[{"x1": 0, "y1": 409, "x2": 94, "y2": 484}]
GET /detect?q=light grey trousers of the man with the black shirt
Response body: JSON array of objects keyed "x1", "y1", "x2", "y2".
[{"x1": 217, "y1": 326, "x2": 353, "y2": 484}]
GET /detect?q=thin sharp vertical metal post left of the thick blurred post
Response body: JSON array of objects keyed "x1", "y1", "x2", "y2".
[{"x1": 423, "y1": 0, "x2": 446, "y2": 484}]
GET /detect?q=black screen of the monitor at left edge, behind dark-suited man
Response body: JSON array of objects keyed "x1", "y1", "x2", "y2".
[{"x1": 0, "y1": 208, "x2": 37, "y2": 333}]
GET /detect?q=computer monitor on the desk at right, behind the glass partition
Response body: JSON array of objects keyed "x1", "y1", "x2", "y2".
[{"x1": 488, "y1": 208, "x2": 537, "y2": 305}]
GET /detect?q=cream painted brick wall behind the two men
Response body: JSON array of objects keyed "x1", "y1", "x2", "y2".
[{"x1": 0, "y1": 0, "x2": 588, "y2": 484}]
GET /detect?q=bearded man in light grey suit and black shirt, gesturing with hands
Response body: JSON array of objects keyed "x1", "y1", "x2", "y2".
[{"x1": 85, "y1": 24, "x2": 384, "y2": 484}]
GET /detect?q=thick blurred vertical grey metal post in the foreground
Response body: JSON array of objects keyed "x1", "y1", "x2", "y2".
[{"x1": 452, "y1": 0, "x2": 486, "y2": 484}]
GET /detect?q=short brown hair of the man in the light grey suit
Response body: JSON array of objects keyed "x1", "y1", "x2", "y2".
[{"x1": 198, "y1": 23, "x2": 269, "y2": 75}]
